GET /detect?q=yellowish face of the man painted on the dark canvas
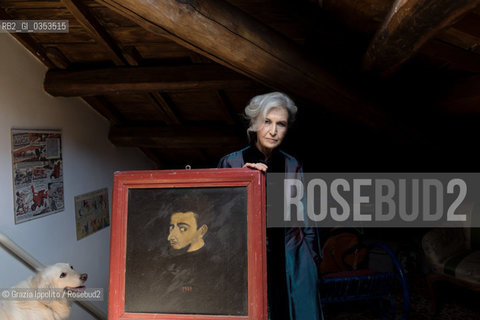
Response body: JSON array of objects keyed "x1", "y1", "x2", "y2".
[{"x1": 168, "y1": 211, "x2": 208, "y2": 252}]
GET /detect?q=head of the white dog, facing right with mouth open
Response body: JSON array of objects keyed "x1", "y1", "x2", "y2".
[{"x1": 32, "y1": 263, "x2": 88, "y2": 291}]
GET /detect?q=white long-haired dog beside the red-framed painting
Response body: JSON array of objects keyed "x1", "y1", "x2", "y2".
[{"x1": 0, "y1": 263, "x2": 88, "y2": 320}]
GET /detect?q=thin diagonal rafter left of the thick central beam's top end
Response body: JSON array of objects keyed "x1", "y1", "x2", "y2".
[{"x1": 62, "y1": 0, "x2": 128, "y2": 66}]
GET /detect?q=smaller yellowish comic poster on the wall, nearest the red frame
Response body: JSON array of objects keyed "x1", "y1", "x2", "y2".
[{"x1": 75, "y1": 188, "x2": 110, "y2": 240}]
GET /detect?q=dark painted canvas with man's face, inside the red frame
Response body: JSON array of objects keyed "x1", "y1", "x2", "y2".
[{"x1": 125, "y1": 187, "x2": 248, "y2": 315}]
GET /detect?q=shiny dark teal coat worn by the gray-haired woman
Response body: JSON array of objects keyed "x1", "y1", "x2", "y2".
[{"x1": 218, "y1": 147, "x2": 323, "y2": 320}]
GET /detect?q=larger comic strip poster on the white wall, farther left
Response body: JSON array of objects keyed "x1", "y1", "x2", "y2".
[{"x1": 12, "y1": 129, "x2": 64, "y2": 223}]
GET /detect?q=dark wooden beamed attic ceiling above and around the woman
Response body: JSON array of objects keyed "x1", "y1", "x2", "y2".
[{"x1": 0, "y1": 0, "x2": 480, "y2": 171}]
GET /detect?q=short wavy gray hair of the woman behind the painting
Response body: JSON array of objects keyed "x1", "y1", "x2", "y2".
[{"x1": 245, "y1": 92, "x2": 297, "y2": 138}]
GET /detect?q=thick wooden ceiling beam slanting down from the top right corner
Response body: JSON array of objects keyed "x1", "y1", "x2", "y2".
[{"x1": 363, "y1": 0, "x2": 480, "y2": 76}]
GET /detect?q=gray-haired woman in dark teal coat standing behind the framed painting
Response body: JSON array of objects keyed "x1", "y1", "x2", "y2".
[{"x1": 218, "y1": 92, "x2": 323, "y2": 320}]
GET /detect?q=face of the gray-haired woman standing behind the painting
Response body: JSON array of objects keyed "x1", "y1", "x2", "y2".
[{"x1": 257, "y1": 107, "x2": 288, "y2": 155}]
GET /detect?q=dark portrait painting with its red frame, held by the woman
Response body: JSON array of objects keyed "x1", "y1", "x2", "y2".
[{"x1": 109, "y1": 169, "x2": 267, "y2": 320}]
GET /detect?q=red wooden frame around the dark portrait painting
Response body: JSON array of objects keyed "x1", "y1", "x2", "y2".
[{"x1": 108, "y1": 169, "x2": 267, "y2": 320}]
